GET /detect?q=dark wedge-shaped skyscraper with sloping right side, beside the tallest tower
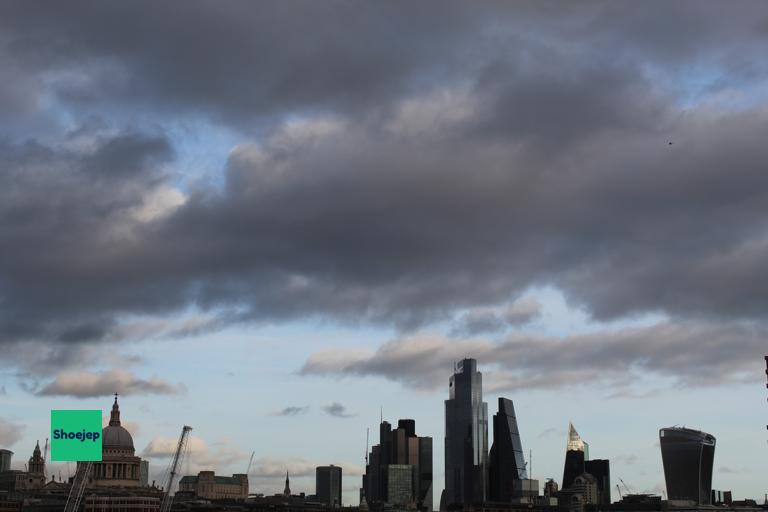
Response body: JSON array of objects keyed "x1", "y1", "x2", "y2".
[{"x1": 488, "y1": 398, "x2": 528, "y2": 502}]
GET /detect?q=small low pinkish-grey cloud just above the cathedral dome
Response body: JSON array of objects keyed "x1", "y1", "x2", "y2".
[{"x1": 35, "y1": 369, "x2": 185, "y2": 398}]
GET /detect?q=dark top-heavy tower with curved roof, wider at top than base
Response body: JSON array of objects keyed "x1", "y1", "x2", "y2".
[{"x1": 659, "y1": 427, "x2": 715, "y2": 505}]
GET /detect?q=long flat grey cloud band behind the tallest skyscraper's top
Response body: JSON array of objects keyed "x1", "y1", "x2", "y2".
[{"x1": 301, "y1": 322, "x2": 768, "y2": 391}]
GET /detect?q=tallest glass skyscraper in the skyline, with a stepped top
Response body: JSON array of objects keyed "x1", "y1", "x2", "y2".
[{"x1": 441, "y1": 359, "x2": 488, "y2": 505}]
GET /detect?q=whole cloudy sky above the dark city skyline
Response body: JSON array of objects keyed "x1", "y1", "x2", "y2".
[{"x1": 0, "y1": 0, "x2": 768, "y2": 503}]
